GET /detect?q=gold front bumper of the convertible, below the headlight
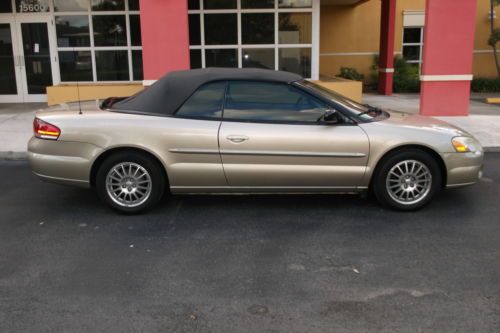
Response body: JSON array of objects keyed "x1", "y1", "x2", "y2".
[{"x1": 442, "y1": 151, "x2": 484, "y2": 188}]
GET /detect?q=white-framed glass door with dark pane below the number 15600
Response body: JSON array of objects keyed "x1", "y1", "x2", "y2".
[{"x1": 16, "y1": 17, "x2": 58, "y2": 102}]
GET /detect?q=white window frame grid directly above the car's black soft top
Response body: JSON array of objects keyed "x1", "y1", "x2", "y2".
[{"x1": 188, "y1": 0, "x2": 320, "y2": 79}]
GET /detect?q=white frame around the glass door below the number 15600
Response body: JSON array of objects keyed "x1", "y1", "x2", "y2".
[{"x1": 14, "y1": 13, "x2": 60, "y2": 103}]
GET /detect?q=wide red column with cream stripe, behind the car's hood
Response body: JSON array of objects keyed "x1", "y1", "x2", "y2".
[{"x1": 420, "y1": 0, "x2": 476, "y2": 116}]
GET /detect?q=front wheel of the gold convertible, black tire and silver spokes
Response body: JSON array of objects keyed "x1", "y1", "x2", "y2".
[{"x1": 372, "y1": 149, "x2": 442, "y2": 211}]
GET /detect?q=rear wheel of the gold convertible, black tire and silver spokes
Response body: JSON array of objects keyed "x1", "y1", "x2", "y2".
[{"x1": 96, "y1": 152, "x2": 167, "y2": 214}]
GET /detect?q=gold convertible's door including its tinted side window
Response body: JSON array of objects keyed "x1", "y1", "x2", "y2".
[{"x1": 219, "y1": 81, "x2": 369, "y2": 191}]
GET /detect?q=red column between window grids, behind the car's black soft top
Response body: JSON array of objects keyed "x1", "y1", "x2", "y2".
[{"x1": 140, "y1": 0, "x2": 190, "y2": 81}]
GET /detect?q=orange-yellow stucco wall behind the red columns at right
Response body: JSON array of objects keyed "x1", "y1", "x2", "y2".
[{"x1": 319, "y1": 0, "x2": 500, "y2": 81}]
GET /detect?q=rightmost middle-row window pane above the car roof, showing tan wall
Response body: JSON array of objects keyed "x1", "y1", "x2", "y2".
[{"x1": 279, "y1": 13, "x2": 312, "y2": 44}]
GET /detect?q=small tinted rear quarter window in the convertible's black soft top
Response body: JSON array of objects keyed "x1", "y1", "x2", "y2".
[{"x1": 176, "y1": 81, "x2": 226, "y2": 119}]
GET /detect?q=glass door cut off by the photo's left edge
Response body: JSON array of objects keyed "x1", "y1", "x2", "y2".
[{"x1": 0, "y1": 18, "x2": 23, "y2": 103}]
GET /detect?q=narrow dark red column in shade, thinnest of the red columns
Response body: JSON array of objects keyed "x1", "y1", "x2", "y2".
[{"x1": 378, "y1": 0, "x2": 396, "y2": 95}]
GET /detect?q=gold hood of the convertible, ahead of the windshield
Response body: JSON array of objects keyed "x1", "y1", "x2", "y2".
[{"x1": 379, "y1": 110, "x2": 472, "y2": 137}]
